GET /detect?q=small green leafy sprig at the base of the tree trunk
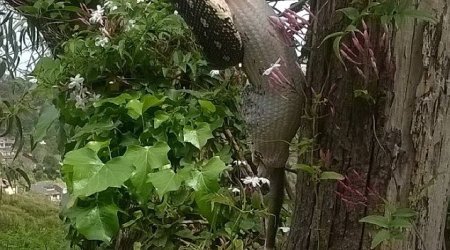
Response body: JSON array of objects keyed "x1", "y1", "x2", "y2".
[{"x1": 359, "y1": 202, "x2": 416, "y2": 249}]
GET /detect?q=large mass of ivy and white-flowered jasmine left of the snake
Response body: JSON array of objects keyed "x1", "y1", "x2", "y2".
[{"x1": 28, "y1": 1, "x2": 264, "y2": 249}]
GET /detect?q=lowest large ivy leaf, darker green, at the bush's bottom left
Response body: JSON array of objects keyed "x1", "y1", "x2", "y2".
[{"x1": 67, "y1": 198, "x2": 119, "y2": 242}]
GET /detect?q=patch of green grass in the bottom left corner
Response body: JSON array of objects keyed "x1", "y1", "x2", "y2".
[{"x1": 0, "y1": 195, "x2": 68, "y2": 249}]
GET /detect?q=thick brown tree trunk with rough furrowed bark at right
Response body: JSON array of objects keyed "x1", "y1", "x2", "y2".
[{"x1": 288, "y1": 0, "x2": 450, "y2": 250}]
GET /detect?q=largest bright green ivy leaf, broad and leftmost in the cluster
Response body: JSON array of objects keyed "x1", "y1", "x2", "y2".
[{"x1": 64, "y1": 148, "x2": 133, "y2": 196}]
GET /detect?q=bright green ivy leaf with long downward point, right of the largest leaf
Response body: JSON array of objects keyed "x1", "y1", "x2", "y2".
[{"x1": 124, "y1": 142, "x2": 170, "y2": 203}]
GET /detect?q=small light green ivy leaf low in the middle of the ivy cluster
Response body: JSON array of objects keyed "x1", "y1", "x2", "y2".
[{"x1": 148, "y1": 169, "x2": 182, "y2": 198}]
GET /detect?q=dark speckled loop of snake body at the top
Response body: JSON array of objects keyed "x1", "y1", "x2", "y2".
[{"x1": 172, "y1": 0, "x2": 243, "y2": 69}]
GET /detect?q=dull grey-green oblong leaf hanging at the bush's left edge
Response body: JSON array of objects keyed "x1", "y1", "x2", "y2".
[{"x1": 31, "y1": 103, "x2": 59, "y2": 149}]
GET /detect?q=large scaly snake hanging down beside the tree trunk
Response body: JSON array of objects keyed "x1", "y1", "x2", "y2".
[{"x1": 172, "y1": 0, "x2": 305, "y2": 249}]
